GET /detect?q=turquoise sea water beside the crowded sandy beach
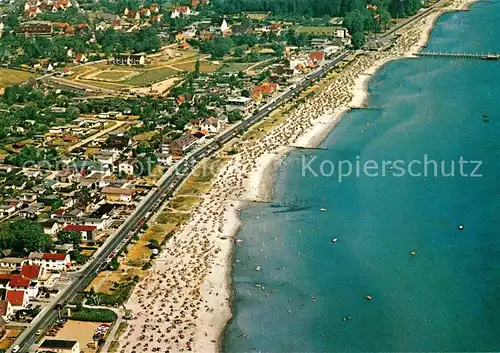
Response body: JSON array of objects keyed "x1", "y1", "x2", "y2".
[{"x1": 223, "y1": 2, "x2": 500, "y2": 352}]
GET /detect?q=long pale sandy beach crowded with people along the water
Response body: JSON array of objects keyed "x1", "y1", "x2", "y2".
[{"x1": 111, "y1": 0, "x2": 478, "y2": 353}]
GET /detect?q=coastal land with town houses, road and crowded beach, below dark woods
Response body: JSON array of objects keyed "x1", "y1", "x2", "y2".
[{"x1": 0, "y1": 0, "x2": 476, "y2": 353}]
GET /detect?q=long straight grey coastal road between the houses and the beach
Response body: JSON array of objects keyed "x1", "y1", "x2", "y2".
[{"x1": 9, "y1": 51, "x2": 352, "y2": 353}]
